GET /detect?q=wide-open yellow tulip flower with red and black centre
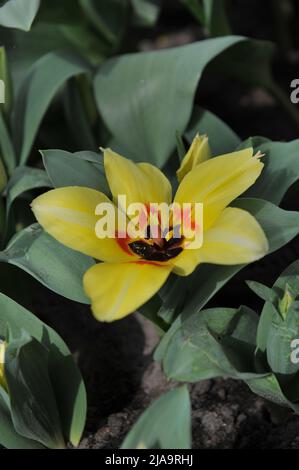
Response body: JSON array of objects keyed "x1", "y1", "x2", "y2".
[{"x1": 32, "y1": 136, "x2": 268, "y2": 322}]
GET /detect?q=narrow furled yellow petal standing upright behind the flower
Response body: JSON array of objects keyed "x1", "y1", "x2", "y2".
[{"x1": 177, "y1": 134, "x2": 211, "y2": 182}]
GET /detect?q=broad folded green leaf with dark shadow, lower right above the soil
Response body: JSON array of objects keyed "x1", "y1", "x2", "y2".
[{"x1": 163, "y1": 307, "x2": 264, "y2": 382}]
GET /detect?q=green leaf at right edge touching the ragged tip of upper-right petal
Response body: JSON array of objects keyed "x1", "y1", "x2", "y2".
[{"x1": 246, "y1": 140, "x2": 299, "y2": 204}]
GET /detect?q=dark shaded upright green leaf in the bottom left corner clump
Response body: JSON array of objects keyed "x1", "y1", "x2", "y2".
[{"x1": 5, "y1": 337, "x2": 65, "y2": 449}]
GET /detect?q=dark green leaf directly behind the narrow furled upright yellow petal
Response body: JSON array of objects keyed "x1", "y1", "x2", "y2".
[{"x1": 185, "y1": 106, "x2": 241, "y2": 156}]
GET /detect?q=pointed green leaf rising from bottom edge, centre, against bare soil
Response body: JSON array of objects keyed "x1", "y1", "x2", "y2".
[{"x1": 121, "y1": 386, "x2": 191, "y2": 449}]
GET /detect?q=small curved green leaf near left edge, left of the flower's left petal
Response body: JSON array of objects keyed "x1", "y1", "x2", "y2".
[{"x1": 6, "y1": 166, "x2": 52, "y2": 216}]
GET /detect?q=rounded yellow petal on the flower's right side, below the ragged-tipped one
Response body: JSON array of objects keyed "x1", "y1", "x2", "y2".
[{"x1": 199, "y1": 207, "x2": 269, "y2": 265}]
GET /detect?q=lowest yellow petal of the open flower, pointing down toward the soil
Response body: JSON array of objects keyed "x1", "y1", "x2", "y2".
[{"x1": 83, "y1": 262, "x2": 171, "y2": 322}]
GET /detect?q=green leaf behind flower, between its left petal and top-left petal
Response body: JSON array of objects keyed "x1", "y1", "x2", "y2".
[{"x1": 41, "y1": 150, "x2": 109, "y2": 194}]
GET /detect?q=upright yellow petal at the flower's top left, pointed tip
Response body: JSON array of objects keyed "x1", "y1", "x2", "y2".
[{"x1": 104, "y1": 149, "x2": 172, "y2": 205}]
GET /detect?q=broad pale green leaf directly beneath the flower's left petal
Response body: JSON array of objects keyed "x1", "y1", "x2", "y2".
[{"x1": 0, "y1": 224, "x2": 94, "y2": 303}]
